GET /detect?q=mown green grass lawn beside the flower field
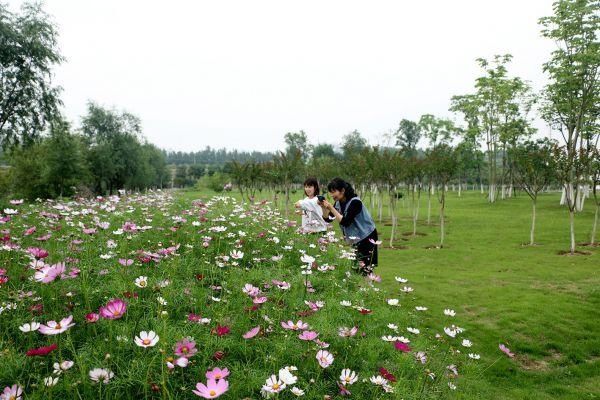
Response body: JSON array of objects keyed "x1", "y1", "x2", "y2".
[{"x1": 186, "y1": 188, "x2": 600, "y2": 399}]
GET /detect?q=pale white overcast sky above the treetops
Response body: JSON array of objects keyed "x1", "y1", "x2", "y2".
[{"x1": 8, "y1": 0, "x2": 553, "y2": 151}]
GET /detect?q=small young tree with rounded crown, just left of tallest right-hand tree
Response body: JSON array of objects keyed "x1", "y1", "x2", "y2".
[{"x1": 511, "y1": 139, "x2": 556, "y2": 246}]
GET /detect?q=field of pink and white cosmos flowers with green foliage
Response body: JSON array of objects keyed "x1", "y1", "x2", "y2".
[{"x1": 0, "y1": 191, "x2": 478, "y2": 399}]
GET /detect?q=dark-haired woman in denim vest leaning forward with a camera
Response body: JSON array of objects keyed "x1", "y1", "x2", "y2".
[{"x1": 321, "y1": 178, "x2": 378, "y2": 275}]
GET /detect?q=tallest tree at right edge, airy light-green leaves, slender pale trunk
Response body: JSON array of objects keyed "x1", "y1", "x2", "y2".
[{"x1": 539, "y1": 0, "x2": 600, "y2": 253}]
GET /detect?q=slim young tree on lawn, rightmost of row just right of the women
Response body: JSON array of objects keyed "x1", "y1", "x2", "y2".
[{"x1": 427, "y1": 143, "x2": 458, "y2": 248}]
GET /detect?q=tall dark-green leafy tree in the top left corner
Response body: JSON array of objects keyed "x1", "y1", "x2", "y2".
[{"x1": 0, "y1": 3, "x2": 63, "y2": 148}]
